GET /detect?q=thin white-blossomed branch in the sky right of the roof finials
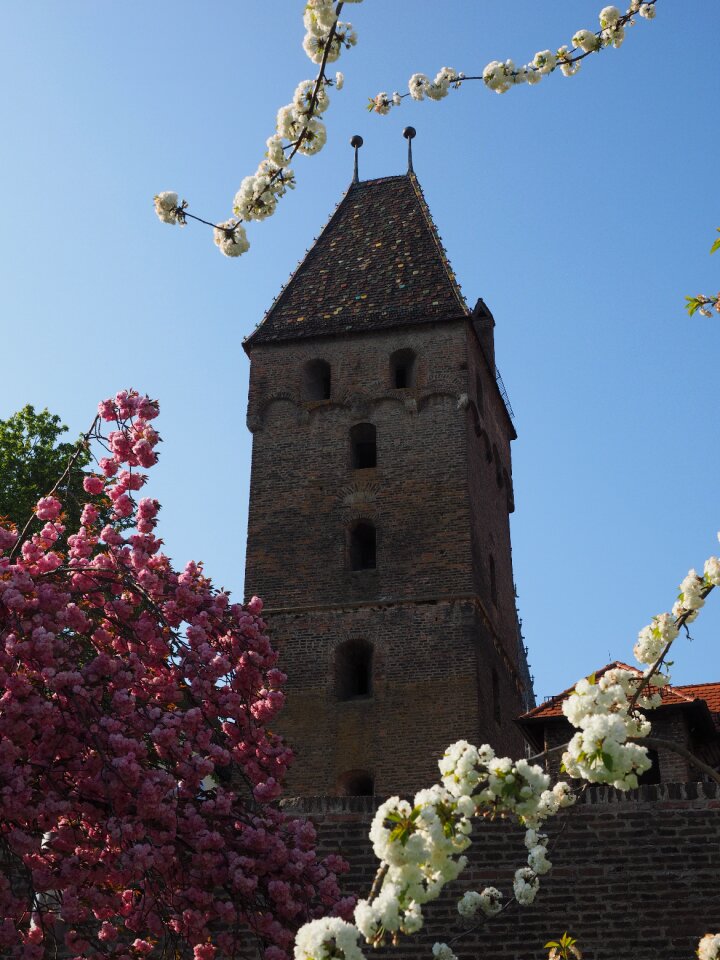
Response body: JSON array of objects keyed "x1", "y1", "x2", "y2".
[{"x1": 368, "y1": 0, "x2": 657, "y2": 115}]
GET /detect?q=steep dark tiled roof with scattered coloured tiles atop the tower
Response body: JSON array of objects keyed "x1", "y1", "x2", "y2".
[{"x1": 245, "y1": 174, "x2": 469, "y2": 347}]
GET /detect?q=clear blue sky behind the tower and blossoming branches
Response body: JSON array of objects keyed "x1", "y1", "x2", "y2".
[{"x1": 0, "y1": 0, "x2": 720, "y2": 697}]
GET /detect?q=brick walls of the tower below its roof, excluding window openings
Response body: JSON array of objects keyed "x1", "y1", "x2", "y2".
[{"x1": 245, "y1": 319, "x2": 522, "y2": 794}]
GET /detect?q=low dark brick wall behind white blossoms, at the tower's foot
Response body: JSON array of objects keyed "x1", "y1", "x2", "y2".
[{"x1": 284, "y1": 783, "x2": 720, "y2": 960}]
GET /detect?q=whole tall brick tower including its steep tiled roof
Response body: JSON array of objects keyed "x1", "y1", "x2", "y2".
[{"x1": 245, "y1": 174, "x2": 532, "y2": 796}]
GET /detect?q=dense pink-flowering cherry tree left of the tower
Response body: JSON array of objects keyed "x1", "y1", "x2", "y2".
[{"x1": 0, "y1": 391, "x2": 353, "y2": 960}]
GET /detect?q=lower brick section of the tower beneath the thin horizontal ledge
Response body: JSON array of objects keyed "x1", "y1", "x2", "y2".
[{"x1": 270, "y1": 596, "x2": 523, "y2": 796}]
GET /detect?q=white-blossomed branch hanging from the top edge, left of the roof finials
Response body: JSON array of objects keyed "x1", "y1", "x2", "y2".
[{"x1": 154, "y1": 0, "x2": 362, "y2": 257}]
